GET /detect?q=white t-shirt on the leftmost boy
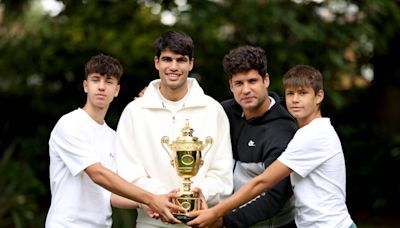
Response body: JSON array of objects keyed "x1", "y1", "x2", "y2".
[{"x1": 46, "y1": 108, "x2": 116, "y2": 228}]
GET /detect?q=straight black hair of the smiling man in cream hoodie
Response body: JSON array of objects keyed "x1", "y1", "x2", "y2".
[{"x1": 155, "y1": 31, "x2": 194, "y2": 60}]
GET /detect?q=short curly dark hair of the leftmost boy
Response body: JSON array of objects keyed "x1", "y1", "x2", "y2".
[{"x1": 85, "y1": 54, "x2": 124, "y2": 82}]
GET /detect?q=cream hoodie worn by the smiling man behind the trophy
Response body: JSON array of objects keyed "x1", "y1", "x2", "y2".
[{"x1": 116, "y1": 78, "x2": 233, "y2": 226}]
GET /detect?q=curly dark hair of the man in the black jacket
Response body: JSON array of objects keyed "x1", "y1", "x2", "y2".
[{"x1": 222, "y1": 45, "x2": 267, "y2": 78}]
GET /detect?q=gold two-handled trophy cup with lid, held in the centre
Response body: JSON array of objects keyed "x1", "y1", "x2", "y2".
[{"x1": 161, "y1": 120, "x2": 213, "y2": 222}]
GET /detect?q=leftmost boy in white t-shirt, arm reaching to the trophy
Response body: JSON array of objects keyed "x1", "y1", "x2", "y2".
[{"x1": 46, "y1": 54, "x2": 179, "y2": 228}]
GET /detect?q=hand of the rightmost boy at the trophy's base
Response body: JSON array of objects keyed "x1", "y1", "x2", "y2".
[{"x1": 186, "y1": 208, "x2": 221, "y2": 228}]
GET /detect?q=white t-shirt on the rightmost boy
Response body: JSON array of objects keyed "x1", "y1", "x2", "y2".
[{"x1": 278, "y1": 118, "x2": 353, "y2": 228}]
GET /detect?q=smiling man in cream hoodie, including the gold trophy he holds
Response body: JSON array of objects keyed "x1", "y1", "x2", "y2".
[{"x1": 116, "y1": 31, "x2": 233, "y2": 227}]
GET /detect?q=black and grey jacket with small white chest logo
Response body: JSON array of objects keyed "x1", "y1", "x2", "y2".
[{"x1": 222, "y1": 93, "x2": 297, "y2": 228}]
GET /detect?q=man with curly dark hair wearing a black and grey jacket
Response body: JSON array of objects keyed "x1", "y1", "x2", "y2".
[{"x1": 219, "y1": 46, "x2": 297, "y2": 228}]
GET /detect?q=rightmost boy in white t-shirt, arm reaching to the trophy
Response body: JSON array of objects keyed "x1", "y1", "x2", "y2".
[{"x1": 187, "y1": 65, "x2": 356, "y2": 228}]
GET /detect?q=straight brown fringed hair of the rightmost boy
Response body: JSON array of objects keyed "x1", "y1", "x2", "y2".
[{"x1": 282, "y1": 64, "x2": 323, "y2": 93}]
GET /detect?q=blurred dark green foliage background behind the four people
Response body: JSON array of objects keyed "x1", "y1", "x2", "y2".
[{"x1": 0, "y1": 0, "x2": 400, "y2": 227}]
